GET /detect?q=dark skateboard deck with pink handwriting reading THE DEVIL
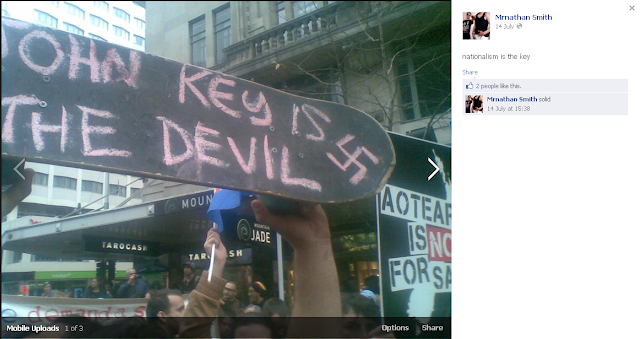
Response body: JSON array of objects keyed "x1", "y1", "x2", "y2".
[{"x1": 2, "y1": 18, "x2": 395, "y2": 203}]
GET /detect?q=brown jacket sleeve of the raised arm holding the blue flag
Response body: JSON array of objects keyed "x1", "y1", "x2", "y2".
[{"x1": 180, "y1": 271, "x2": 227, "y2": 338}]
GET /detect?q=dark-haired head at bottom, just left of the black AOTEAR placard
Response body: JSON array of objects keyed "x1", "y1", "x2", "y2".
[{"x1": 341, "y1": 293, "x2": 380, "y2": 338}]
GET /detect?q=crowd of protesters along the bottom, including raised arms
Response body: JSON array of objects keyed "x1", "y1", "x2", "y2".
[{"x1": 8, "y1": 195, "x2": 392, "y2": 338}]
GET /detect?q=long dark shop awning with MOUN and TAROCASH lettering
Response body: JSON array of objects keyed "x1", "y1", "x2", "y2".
[{"x1": 2, "y1": 190, "x2": 376, "y2": 260}]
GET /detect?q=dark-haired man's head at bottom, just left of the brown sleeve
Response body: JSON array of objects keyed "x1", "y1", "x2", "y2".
[{"x1": 147, "y1": 289, "x2": 184, "y2": 335}]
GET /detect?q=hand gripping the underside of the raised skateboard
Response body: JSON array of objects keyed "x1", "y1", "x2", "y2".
[{"x1": 251, "y1": 200, "x2": 331, "y2": 251}]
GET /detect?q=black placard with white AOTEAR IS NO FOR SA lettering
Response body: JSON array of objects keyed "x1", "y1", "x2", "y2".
[{"x1": 377, "y1": 133, "x2": 452, "y2": 318}]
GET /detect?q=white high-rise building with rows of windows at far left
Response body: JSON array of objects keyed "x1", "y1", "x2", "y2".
[{"x1": 2, "y1": 1, "x2": 146, "y2": 294}]
